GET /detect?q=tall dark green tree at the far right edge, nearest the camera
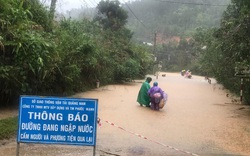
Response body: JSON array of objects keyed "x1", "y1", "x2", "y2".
[{"x1": 216, "y1": 0, "x2": 250, "y2": 101}]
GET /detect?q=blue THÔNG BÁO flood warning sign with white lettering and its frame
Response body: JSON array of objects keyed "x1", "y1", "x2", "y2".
[{"x1": 17, "y1": 95, "x2": 98, "y2": 155}]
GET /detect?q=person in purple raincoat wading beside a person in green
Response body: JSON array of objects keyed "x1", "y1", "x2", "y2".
[{"x1": 148, "y1": 82, "x2": 163, "y2": 110}]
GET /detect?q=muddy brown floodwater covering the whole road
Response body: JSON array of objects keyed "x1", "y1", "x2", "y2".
[{"x1": 0, "y1": 73, "x2": 250, "y2": 156}]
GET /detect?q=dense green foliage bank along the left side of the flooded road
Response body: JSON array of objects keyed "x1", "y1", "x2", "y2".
[{"x1": 0, "y1": 0, "x2": 152, "y2": 106}]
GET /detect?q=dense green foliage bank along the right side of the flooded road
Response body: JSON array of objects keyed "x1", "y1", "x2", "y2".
[{"x1": 191, "y1": 0, "x2": 250, "y2": 103}]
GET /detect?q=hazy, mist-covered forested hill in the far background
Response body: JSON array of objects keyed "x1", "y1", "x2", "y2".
[{"x1": 124, "y1": 0, "x2": 230, "y2": 42}]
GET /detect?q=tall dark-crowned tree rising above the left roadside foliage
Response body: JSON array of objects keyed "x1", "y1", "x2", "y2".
[{"x1": 94, "y1": 0, "x2": 152, "y2": 81}]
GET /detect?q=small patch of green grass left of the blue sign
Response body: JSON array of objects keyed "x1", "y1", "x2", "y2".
[{"x1": 0, "y1": 117, "x2": 18, "y2": 140}]
